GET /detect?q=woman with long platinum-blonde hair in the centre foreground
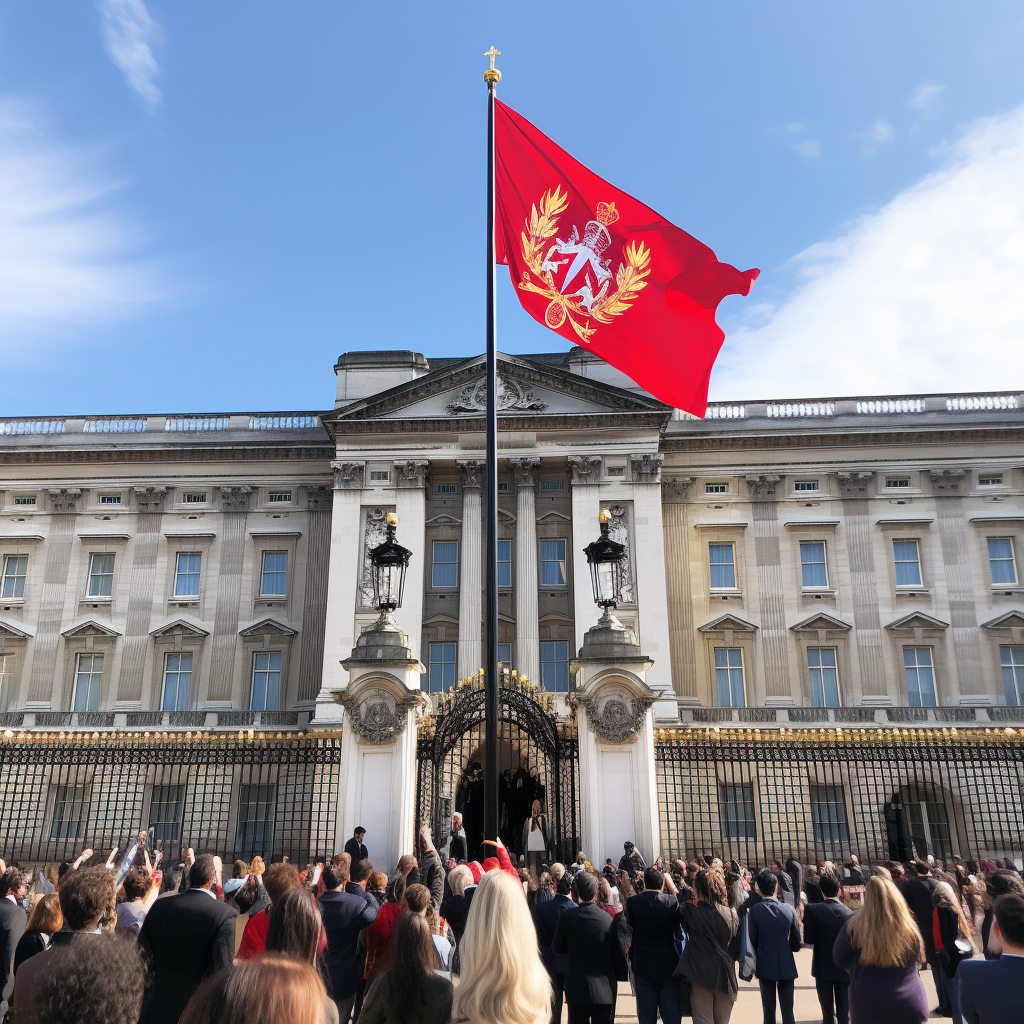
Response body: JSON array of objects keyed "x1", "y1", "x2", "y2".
[{"x1": 452, "y1": 871, "x2": 551, "y2": 1024}]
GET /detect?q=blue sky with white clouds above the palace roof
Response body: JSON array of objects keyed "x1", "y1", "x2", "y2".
[{"x1": 0, "y1": 0, "x2": 1024, "y2": 416}]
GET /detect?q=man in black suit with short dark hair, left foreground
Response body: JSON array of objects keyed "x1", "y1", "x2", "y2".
[{"x1": 138, "y1": 853, "x2": 239, "y2": 1024}]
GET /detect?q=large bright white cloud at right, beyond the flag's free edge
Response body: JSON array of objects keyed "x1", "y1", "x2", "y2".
[{"x1": 713, "y1": 106, "x2": 1024, "y2": 398}]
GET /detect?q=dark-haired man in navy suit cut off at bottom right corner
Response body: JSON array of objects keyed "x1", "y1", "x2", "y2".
[{"x1": 956, "y1": 892, "x2": 1024, "y2": 1024}]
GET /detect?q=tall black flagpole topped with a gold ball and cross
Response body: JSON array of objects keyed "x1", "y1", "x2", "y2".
[{"x1": 483, "y1": 46, "x2": 502, "y2": 839}]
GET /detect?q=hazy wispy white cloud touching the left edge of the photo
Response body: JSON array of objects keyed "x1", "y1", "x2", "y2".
[{"x1": 0, "y1": 99, "x2": 172, "y2": 356}]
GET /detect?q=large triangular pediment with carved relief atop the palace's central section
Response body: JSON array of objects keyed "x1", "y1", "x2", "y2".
[{"x1": 324, "y1": 353, "x2": 671, "y2": 425}]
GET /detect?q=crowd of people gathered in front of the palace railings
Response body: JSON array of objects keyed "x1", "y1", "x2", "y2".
[{"x1": 0, "y1": 831, "x2": 1024, "y2": 1024}]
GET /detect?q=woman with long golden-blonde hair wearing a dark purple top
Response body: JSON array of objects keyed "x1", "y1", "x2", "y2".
[{"x1": 833, "y1": 876, "x2": 928, "y2": 1024}]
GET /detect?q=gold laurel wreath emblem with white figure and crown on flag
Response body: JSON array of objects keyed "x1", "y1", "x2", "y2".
[{"x1": 519, "y1": 185, "x2": 650, "y2": 343}]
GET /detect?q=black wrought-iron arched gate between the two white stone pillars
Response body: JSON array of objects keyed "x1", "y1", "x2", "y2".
[{"x1": 416, "y1": 677, "x2": 581, "y2": 860}]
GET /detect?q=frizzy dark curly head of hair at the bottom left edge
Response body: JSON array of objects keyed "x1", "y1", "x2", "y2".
[{"x1": 38, "y1": 937, "x2": 146, "y2": 1024}]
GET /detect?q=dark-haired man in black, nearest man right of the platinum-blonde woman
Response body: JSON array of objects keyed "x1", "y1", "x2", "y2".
[{"x1": 551, "y1": 871, "x2": 626, "y2": 1024}]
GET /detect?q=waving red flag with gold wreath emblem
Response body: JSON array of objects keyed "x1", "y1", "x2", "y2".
[{"x1": 495, "y1": 99, "x2": 760, "y2": 416}]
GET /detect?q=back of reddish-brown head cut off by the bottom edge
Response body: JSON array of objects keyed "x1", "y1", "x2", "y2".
[{"x1": 178, "y1": 953, "x2": 327, "y2": 1024}]
